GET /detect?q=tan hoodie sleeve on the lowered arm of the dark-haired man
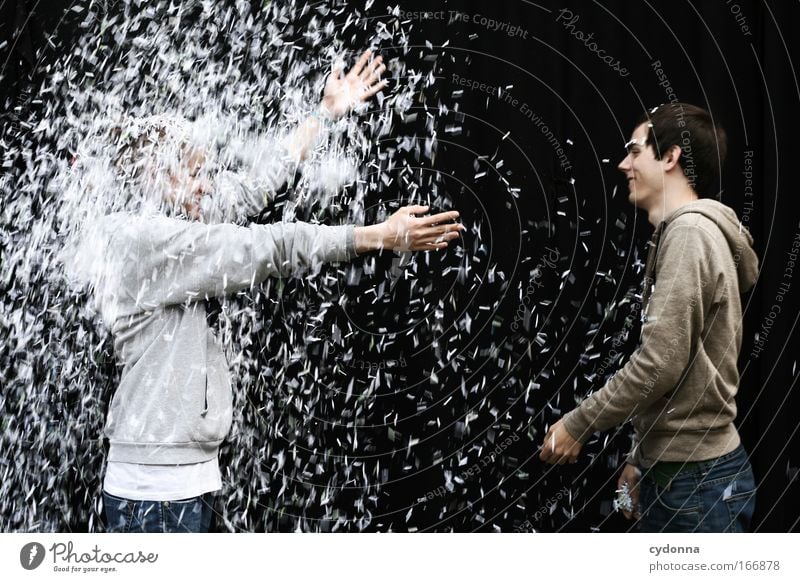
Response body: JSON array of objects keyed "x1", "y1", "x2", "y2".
[{"x1": 563, "y1": 218, "x2": 719, "y2": 443}]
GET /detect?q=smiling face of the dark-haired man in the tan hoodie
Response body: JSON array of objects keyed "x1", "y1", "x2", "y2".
[{"x1": 617, "y1": 123, "x2": 664, "y2": 210}]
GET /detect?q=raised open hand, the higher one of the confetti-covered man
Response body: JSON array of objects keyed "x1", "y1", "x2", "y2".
[{"x1": 322, "y1": 50, "x2": 388, "y2": 119}]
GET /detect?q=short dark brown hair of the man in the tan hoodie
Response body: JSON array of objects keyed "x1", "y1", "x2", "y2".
[{"x1": 636, "y1": 103, "x2": 728, "y2": 198}]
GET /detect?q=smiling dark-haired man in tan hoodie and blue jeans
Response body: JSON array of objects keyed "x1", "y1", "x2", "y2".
[{"x1": 540, "y1": 103, "x2": 758, "y2": 532}]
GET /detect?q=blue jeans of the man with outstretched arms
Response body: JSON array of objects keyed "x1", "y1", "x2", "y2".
[{"x1": 103, "y1": 491, "x2": 214, "y2": 533}]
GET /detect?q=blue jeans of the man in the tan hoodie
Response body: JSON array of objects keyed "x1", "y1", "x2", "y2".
[{"x1": 639, "y1": 445, "x2": 756, "y2": 532}]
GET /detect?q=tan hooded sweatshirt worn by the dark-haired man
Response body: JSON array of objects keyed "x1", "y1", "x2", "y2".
[{"x1": 564, "y1": 199, "x2": 758, "y2": 467}]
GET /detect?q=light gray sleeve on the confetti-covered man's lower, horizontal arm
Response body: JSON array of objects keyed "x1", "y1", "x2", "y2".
[{"x1": 117, "y1": 217, "x2": 356, "y2": 309}]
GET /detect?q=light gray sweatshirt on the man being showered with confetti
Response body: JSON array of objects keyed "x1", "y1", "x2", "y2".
[{"x1": 98, "y1": 214, "x2": 356, "y2": 464}]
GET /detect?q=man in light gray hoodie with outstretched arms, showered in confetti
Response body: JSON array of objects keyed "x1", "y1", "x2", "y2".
[{"x1": 96, "y1": 53, "x2": 463, "y2": 532}]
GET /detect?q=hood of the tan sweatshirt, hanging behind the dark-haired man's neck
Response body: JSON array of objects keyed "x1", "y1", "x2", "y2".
[{"x1": 665, "y1": 198, "x2": 758, "y2": 293}]
